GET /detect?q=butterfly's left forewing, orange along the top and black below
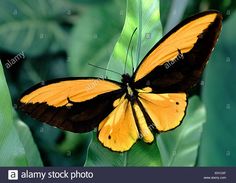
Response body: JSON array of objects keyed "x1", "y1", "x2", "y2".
[{"x1": 18, "y1": 78, "x2": 123, "y2": 132}]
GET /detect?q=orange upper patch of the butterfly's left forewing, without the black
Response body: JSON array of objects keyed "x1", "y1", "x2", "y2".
[{"x1": 20, "y1": 79, "x2": 120, "y2": 107}]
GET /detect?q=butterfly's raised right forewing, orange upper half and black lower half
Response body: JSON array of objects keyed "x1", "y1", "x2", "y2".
[{"x1": 134, "y1": 11, "x2": 222, "y2": 93}]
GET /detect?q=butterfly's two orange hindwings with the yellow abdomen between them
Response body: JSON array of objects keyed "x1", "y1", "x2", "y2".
[{"x1": 98, "y1": 91, "x2": 187, "y2": 152}]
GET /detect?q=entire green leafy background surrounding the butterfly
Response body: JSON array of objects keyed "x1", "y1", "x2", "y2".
[{"x1": 0, "y1": 0, "x2": 236, "y2": 166}]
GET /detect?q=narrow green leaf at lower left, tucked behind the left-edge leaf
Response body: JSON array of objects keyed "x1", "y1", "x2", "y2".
[{"x1": 16, "y1": 116, "x2": 43, "y2": 166}]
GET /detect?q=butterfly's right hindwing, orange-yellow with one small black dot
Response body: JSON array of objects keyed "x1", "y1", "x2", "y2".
[{"x1": 139, "y1": 93, "x2": 187, "y2": 131}]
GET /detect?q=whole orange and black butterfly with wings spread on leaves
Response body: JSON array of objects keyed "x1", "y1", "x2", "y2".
[{"x1": 18, "y1": 11, "x2": 222, "y2": 152}]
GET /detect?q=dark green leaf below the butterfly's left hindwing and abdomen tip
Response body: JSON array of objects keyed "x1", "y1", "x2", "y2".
[{"x1": 85, "y1": 133, "x2": 161, "y2": 167}]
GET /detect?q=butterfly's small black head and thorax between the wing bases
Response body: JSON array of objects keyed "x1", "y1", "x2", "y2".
[{"x1": 121, "y1": 74, "x2": 136, "y2": 101}]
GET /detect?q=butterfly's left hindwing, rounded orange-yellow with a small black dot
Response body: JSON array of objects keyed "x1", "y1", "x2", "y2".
[{"x1": 98, "y1": 96, "x2": 139, "y2": 152}]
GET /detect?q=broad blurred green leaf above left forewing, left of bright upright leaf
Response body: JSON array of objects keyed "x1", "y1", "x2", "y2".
[{"x1": 68, "y1": 0, "x2": 125, "y2": 77}]
